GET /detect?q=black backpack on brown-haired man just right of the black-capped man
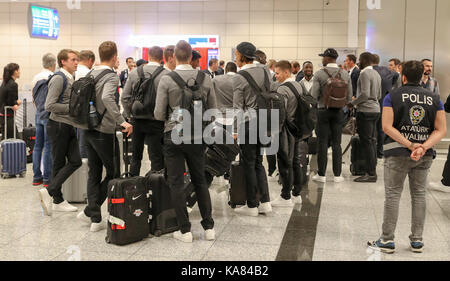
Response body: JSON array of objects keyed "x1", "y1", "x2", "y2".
[{"x1": 283, "y1": 82, "x2": 317, "y2": 139}]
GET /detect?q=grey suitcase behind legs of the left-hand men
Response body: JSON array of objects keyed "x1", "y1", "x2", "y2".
[{"x1": 62, "y1": 158, "x2": 89, "y2": 203}]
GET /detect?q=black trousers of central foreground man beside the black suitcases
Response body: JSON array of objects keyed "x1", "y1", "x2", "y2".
[{"x1": 164, "y1": 132, "x2": 214, "y2": 233}]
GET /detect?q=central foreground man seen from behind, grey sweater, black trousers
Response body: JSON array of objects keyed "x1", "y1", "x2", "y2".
[{"x1": 155, "y1": 41, "x2": 216, "y2": 243}]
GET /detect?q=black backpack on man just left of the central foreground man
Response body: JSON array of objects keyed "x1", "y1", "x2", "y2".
[{"x1": 131, "y1": 65, "x2": 164, "y2": 117}]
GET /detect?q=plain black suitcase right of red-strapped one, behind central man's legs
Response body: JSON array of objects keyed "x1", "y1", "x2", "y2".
[{"x1": 146, "y1": 170, "x2": 193, "y2": 236}]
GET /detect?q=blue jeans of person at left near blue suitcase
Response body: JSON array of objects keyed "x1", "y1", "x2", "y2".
[{"x1": 33, "y1": 115, "x2": 52, "y2": 181}]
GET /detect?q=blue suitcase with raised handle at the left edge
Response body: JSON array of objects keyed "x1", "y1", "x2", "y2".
[{"x1": 0, "y1": 106, "x2": 27, "y2": 178}]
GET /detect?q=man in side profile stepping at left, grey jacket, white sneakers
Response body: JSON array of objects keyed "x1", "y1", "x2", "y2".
[{"x1": 39, "y1": 49, "x2": 81, "y2": 216}]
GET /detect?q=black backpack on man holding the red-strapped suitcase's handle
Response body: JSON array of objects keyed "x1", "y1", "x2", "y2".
[{"x1": 69, "y1": 69, "x2": 115, "y2": 129}]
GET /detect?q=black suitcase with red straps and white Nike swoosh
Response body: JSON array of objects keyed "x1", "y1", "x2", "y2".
[{"x1": 105, "y1": 132, "x2": 151, "y2": 245}]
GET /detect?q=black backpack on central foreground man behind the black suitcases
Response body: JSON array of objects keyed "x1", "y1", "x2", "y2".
[{"x1": 167, "y1": 71, "x2": 207, "y2": 140}]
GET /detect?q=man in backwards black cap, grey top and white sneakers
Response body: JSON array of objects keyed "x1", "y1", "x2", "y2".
[{"x1": 233, "y1": 42, "x2": 272, "y2": 217}]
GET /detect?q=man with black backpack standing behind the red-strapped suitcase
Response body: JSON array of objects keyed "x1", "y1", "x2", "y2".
[{"x1": 122, "y1": 46, "x2": 169, "y2": 176}]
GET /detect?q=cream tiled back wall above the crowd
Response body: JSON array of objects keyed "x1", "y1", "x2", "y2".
[{"x1": 0, "y1": 0, "x2": 365, "y2": 87}]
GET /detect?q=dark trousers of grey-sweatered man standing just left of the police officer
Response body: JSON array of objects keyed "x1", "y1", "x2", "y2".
[{"x1": 356, "y1": 112, "x2": 380, "y2": 176}]
